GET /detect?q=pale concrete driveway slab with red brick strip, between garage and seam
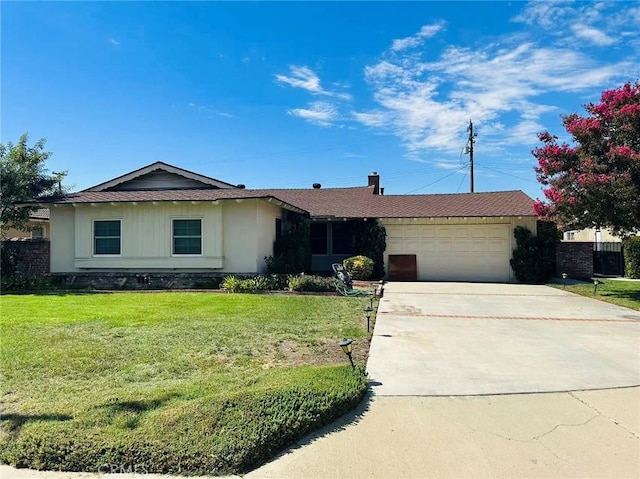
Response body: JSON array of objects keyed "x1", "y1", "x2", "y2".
[{"x1": 367, "y1": 283, "x2": 640, "y2": 396}]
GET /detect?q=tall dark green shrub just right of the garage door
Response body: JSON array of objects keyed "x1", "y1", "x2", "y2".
[{"x1": 509, "y1": 221, "x2": 560, "y2": 283}]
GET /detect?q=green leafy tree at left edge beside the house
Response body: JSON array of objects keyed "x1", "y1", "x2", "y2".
[{"x1": 0, "y1": 133, "x2": 65, "y2": 230}]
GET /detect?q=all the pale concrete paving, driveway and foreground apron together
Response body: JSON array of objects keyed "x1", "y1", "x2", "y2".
[{"x1": 0, "y1": 283, "x2": 640, "y2": 479}]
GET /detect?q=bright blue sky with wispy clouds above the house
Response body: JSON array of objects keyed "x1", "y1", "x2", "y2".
[{"x1": 0, "y1": 1, "x2": 640, "y2": 198}]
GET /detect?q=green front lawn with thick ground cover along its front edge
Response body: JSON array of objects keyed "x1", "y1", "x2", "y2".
[{"x1": 0, "y1": 293, "x2": 368, "y2": 475}]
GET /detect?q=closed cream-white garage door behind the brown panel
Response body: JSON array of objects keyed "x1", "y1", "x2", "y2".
[{"x1": 385, "y1": 224, "x2": 511, "y2": 282}]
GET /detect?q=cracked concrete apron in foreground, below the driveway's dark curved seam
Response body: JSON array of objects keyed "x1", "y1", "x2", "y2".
[{"x1": 246, "y1": 387, "x2": 640, "y2": 479}]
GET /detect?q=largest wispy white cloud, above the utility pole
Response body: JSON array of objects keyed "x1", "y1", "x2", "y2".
[{"x1": 352, "y1": 16, "x2": 637, "y2": 155}]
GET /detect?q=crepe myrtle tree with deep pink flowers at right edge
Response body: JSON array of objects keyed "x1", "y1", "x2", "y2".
[{"x1": 532, "y1": 81, "x2": 640, "y2": 236}]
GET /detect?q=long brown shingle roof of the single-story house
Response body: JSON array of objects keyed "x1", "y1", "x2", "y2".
[{"x1": 40, "y1": 187, "x2": 533, "y2": 218}]
